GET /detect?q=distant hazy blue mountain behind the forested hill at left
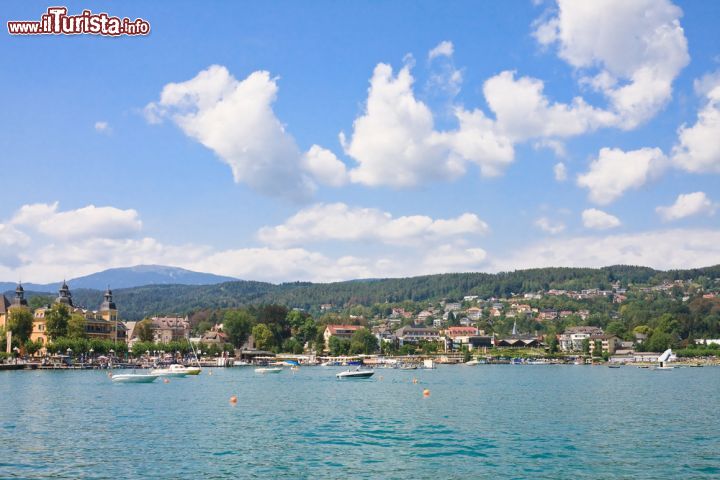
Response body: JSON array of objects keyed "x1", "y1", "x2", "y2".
[{"x1": 0, "y1": 265, "x2": 237, "y2": 293}]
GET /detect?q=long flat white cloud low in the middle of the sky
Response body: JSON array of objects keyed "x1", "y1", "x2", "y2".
[{"x1": 258, "y1": 203, "x2": 488, "y2": 246}]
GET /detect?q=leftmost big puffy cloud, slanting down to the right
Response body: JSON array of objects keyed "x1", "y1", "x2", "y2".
[{"x1": 145, "y1": 65, "x2": 339, "y2": 200}]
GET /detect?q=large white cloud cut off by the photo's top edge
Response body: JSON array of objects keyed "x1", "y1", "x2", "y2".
[{"x1": 535, "y1": 0, "x2": 690, "y2": 129}]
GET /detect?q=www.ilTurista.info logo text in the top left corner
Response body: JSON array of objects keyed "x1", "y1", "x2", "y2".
[{"x1": 7, "y1": 7, "x2": 150, "y2": 37}]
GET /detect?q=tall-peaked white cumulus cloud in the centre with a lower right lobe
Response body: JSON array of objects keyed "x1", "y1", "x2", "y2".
[{"x1": 340, "y1": 63, "x2": 514, "y2": 187}]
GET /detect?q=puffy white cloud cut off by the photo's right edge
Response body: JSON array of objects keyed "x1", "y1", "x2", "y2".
[{"x1": 672, "y1": 79, "x2": 720, "y2": 173}]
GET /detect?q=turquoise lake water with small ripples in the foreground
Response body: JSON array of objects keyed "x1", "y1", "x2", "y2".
[{"x1": 0, "y1": 365, "x2": 720, "y2": 479}]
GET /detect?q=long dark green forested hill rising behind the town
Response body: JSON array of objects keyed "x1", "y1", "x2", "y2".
[{"x1": 12, "y1": 265, "x2": 720, "y2": 320}]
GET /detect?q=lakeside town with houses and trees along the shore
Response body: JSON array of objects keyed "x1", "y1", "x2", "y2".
[{"x1": 0, "y1": 279, "x2": 720, "y2": 366}]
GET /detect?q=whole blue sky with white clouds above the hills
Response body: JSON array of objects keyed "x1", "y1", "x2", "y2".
[{"x1": 0, "y1": 0, "x2": 720, "y2": 281}]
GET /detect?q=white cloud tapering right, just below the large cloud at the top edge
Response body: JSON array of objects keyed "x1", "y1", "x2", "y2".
[{"x1": 483, "y1": 71, "x2": 616, "y2": 141}]
